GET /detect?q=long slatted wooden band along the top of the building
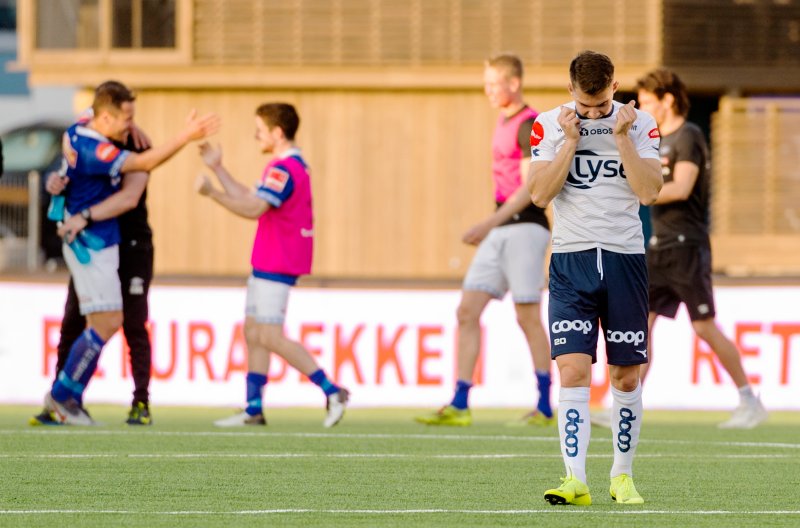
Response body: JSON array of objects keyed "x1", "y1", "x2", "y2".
[{"x1": 194, "y1": 0, "x2": 661, "y2": 66}]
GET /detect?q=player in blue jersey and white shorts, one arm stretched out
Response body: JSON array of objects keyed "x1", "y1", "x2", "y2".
[{"x1": 45, "y1": 81, "x2": 219, "y2": 425}]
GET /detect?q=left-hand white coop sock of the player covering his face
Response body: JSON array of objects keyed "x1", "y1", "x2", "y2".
[{"x1": 558, "y1": 387, "x2": 592, "y2": 483}]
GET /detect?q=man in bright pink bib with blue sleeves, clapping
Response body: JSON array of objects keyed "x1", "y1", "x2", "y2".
[{"x1": 197, "y1": 103, "x2": 349, "y2": 427}]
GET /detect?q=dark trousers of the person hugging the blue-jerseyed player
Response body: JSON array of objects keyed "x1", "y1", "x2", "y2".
[{"x1": 56, "y1": 241, "x2": 153, "y2": 404}]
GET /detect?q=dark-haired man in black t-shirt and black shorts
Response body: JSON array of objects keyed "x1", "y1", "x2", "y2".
[{"x1": 637, "y1": 69, "x2": 767, "y2": 429}]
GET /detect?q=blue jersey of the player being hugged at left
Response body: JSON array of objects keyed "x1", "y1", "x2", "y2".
[{"x1": 62, "y1": 123, "x2": 130, "y2": 247}]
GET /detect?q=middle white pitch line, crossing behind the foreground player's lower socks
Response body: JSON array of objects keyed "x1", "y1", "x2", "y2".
[{"x1": 0, "y1": 453, "x2": 795, "y2": 460}]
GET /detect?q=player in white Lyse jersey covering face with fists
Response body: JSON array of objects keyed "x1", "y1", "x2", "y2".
[{"x1": 528, "y1": 51, "x2": 663, "y2": 506}]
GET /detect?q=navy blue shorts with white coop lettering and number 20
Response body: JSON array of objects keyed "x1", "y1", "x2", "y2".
[{"x1": 548, "y1": 248, "x2": 648, "y2": 366}]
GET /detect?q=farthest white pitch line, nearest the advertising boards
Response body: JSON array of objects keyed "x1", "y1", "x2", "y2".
[{"x1": 0, "y1": 426, "x2": 800, "y2": 450}]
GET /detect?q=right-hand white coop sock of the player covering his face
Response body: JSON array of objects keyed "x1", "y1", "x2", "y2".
[{"x1": 611, "y1": 383, "x2": 642, "y2": 478}]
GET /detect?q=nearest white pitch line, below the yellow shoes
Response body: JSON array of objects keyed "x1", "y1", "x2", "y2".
[{"x1": 0, "y1": 507, "x2": 800, "y2": 517}]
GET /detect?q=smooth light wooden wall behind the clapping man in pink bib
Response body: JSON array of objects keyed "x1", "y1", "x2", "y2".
[{"x1": 131, "y1": 87, "x2": 567, "y2": 278}]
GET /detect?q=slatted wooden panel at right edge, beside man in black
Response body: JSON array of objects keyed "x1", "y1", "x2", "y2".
[{"x1": 711, "y1": 97, "x2": 800, "y2": 275}]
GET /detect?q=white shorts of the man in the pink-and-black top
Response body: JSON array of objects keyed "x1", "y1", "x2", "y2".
[{"x1": 463, "y1": 222, "x2": 550, "y2": 304}]
